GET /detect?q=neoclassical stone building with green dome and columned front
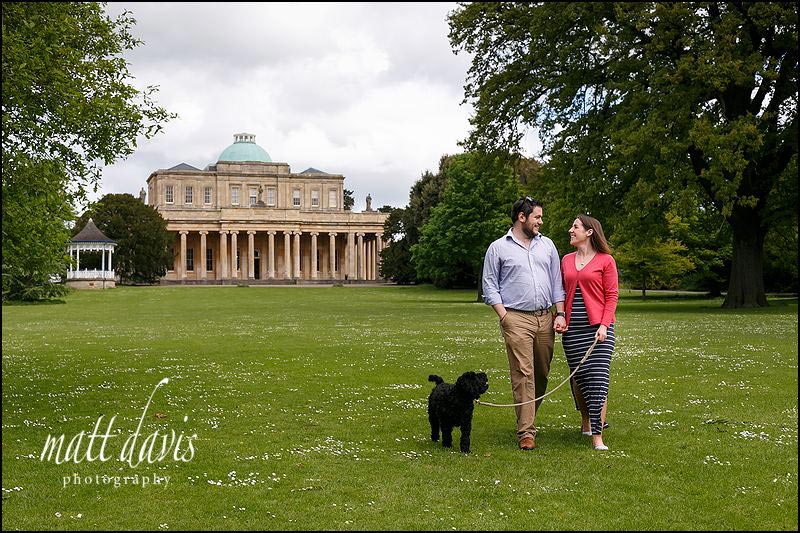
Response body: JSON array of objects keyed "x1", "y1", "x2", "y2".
[{"x1": 150, "y1": 133, "x2": 388, "y2": 284}]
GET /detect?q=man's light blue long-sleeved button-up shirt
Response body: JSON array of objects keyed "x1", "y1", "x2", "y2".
[{"x1": 483, "y1": 229, "x2": 565, "y2": 311}]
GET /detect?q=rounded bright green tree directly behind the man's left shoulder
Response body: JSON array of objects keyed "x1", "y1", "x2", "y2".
[{"x1": 411, "y1": 153, "x2": 521, "y2": 287}]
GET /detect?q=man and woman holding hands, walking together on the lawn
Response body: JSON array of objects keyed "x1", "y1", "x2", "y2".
[{"x1": 483, "y1": 197, "x2": 618, "y2": 450}]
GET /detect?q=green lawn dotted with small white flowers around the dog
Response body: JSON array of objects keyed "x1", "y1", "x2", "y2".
[{"x1": 2, "y1": 287, "x2": 798, "y2": 530}]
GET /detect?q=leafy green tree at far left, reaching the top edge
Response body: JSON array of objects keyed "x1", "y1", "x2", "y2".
[{"x1": 2, "y1": 2, "x2": 174, "y2": 299}]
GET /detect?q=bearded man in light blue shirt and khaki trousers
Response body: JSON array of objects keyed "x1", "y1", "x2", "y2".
[{"x1": 483, "y1": 196, "x2": 567, "y2": 450}]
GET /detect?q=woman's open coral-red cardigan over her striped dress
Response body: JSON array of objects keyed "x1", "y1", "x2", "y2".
[{"x1": 561, "y1": 252, "x2": 619, "y2": 326}]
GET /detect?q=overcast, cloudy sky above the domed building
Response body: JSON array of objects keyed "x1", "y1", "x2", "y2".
[{"x1": 95, "y1": 2, "x2": 530, "y2": 211}]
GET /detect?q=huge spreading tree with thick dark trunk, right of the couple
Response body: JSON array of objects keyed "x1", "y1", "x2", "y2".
[{"x1": 450, "y1": 2, "x2": 798, "y2": 307}]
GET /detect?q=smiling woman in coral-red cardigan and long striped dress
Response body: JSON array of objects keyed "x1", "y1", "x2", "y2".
[{"x1": 561, "y1": 215, "x2": 619, "y2": 450}]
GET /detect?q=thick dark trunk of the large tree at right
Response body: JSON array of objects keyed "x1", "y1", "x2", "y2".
[{"x1": 722, "y1": 207, "x2": 767, "y2": 309}]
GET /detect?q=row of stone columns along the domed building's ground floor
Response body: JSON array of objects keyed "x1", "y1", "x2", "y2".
[{"x1": 172, "y1": 229, "x2": 383, "y2": 281}]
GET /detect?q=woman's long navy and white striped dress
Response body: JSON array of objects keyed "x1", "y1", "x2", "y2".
[{"x1": 561, "y1": 285, "x2": 615, "y2": 435}]
